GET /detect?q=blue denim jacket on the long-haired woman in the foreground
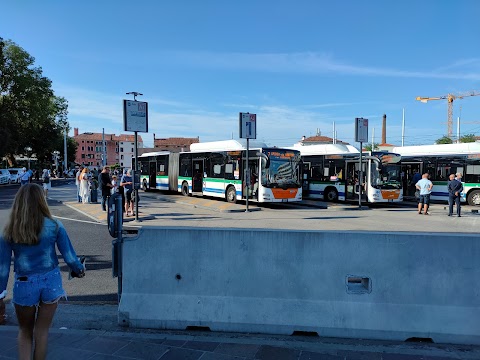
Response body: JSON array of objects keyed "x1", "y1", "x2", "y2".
[{"x1": 0, "y1": 218, "x2": 83, "y2": 293}]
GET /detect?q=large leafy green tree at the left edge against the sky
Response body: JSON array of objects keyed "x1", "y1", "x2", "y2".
[{"x1": 0, "y1": 38, "x2": 69, "y2": 165}]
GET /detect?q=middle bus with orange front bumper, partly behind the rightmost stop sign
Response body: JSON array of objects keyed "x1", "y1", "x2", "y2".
[{"x1": 293, "y1": 144, "x2": 403, "y2": 203}]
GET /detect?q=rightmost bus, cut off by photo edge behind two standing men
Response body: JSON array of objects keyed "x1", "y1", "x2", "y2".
[{"x1": 392, "y1": 142, "x2": 480, "y2": 205}]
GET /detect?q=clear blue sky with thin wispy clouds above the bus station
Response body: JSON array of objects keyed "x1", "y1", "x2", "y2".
[{"x1": 0, "y1": 0, "x2": 480, "y2": 146}]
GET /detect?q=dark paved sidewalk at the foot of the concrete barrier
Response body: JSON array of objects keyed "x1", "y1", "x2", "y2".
[{"x1": 0, "y1": 304, "x2": 480, "y2": 360}]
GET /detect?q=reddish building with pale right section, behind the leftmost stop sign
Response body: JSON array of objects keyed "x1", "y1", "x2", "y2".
[{"x1": 73, "y1": 128, "x2": 143, "y2": 169}]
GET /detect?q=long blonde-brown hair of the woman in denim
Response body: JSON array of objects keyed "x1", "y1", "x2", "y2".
[{"x1": 3, "y1": 183, "x2": 52, "y2": 245}]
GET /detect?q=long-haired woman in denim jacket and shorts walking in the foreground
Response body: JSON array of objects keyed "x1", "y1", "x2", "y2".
[{"x1": 0, "y1": 183, "x2": 85, "y2": 360}]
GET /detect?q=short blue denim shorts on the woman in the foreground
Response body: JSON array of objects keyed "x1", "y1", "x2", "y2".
[{"x1": 13, "y1": 267, "x2": 67, "y2": 306}]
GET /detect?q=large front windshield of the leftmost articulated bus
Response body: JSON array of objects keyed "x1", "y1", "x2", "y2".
[{"x1": 262, "y1": 150, "x2": 301, "y2": 188}]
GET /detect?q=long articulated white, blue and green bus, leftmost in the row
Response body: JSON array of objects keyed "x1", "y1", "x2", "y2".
[{"x1": 138, "y1": 140, "x2": 302, "y2": 203}]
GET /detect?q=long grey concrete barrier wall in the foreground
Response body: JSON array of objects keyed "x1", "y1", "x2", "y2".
[{"x1": 119, "y1": 227, "x2": 480, "y2": 344}]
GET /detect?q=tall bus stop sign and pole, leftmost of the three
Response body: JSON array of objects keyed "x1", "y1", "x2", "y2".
[{"x1": 123, "y1": 91, "x2": 148, "y2": 222}]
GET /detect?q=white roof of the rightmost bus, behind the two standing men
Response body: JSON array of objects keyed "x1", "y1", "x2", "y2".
[{"x1": 392, "y1": 142, "x2": 480, "y2": 156}]
